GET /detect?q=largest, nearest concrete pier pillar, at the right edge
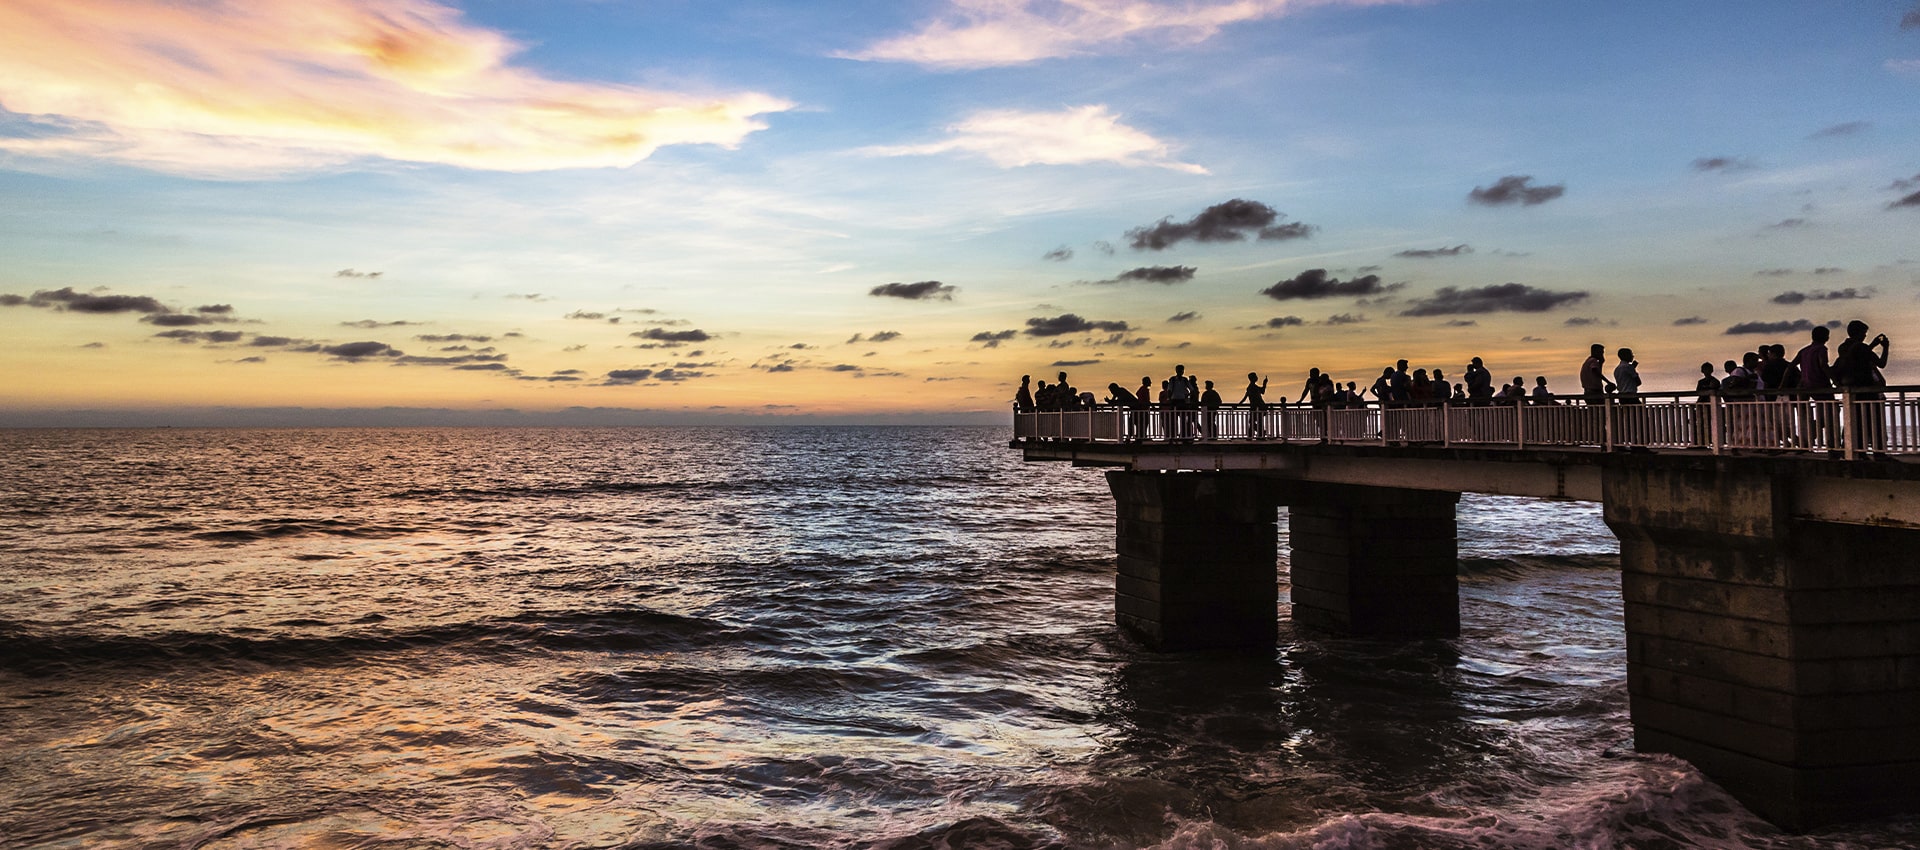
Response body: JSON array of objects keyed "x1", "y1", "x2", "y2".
[{"x1": 1603, "y1": 466, "x2": 1920, "y2": 829}]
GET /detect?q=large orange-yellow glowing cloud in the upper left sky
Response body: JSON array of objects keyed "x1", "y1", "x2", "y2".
[{"x1": 0, "y1": 0, "x2": 791, "y2": 177}]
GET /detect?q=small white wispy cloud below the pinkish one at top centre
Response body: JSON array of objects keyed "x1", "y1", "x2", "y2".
[{"x1": 860, "y1": 104, "x2": 1208, "y2": 175}]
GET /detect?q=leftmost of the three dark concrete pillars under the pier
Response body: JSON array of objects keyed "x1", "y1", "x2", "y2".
[{"x1": 1106, "y1": 470, "x2": 1279, "y2": 650}]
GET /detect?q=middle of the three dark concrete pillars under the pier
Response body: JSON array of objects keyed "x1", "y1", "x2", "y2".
[{"x1": 1279, "y1": 484, "x2": 1459, "y2": 637}]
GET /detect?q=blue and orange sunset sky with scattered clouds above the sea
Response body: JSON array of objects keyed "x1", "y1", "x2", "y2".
[{"x1": 0, "y1": 0, "x2": 1920, "y2": 426}]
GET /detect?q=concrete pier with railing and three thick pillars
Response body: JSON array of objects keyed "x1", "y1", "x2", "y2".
[{"x1": 1012, "y1": 388, "x2": 1920, "y2": 829}]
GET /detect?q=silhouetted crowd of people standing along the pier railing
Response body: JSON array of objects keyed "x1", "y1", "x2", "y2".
[{"x1": 1014, "y1": 320, "x2": 1889, "y2": 451}]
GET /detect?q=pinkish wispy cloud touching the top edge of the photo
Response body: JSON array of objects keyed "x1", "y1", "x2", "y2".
[{"x1": 841, "y1": 0, "x2": 1420, "y2": 69}]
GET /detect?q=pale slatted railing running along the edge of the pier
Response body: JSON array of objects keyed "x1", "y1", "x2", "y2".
[{"x1": 1014, "y1": 386, "x2": 1920, "y2": 460}]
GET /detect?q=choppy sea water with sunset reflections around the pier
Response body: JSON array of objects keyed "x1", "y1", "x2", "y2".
[{"x1": 0, "y1": 428, "x2": 1920, "y2": 848}]
